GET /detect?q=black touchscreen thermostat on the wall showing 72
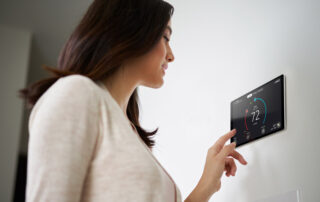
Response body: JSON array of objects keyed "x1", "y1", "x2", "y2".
[{"x1": 231, "y1": 75, "x2": 284, "y2": 147}]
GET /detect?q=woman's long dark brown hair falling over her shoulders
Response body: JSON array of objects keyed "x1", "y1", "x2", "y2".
[{"x1": 19, "y1": 0, "x2": 174, "y2": 149}]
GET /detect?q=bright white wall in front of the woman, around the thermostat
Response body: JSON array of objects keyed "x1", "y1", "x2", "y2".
[{"x1": 140, "y1": 0, "x2": 320, "y2": 202}]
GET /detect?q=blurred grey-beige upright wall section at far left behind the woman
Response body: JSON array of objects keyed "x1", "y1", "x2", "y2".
[{"x1": 0, "y1": 25, "x2": 31, "y2": 202}]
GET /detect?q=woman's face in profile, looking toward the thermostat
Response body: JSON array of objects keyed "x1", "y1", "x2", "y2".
[{"x1": 127, "y1": 20, "x2": 174, "y2": 88}]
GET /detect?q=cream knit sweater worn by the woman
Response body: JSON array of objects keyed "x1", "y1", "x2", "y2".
[{"x1": 26, "y1": 75, "x2": 181, "y2": 202}]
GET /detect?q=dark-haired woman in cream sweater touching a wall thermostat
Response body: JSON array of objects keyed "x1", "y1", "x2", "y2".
[{"x1": 20, "y1": 0, "x2": 246, "y2": 202}]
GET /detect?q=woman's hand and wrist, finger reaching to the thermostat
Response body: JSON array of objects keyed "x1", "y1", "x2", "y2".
[{"x1": 190, "y1": 129, "x2": 247, "y2": 201}]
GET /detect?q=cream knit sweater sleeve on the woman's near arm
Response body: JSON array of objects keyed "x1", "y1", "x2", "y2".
[{"x1": 26, "y1": 75, "x2": 99, "y2": 202}]
